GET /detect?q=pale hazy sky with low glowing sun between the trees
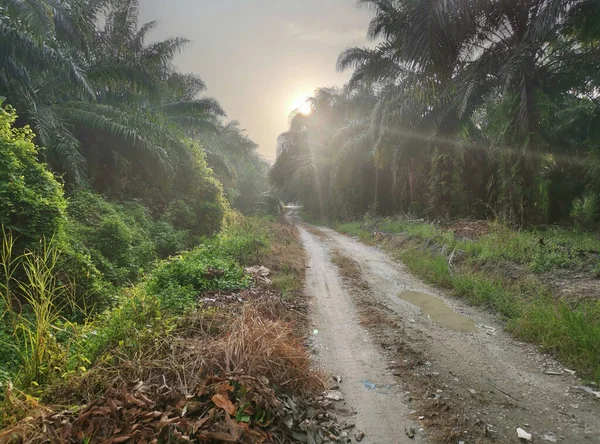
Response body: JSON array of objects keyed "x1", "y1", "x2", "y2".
[{"x1": 140, "y1": 0, "x2": 370, "y2": 162}]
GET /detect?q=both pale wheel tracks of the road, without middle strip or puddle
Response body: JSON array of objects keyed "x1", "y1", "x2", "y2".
[{"x1": 299, "y1": 213, "x2": 600, "y2": 444}]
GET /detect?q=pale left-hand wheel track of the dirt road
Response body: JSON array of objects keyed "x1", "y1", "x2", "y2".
[{"x1": 298, "y1": 220, "x2": 425, "y2": 444}]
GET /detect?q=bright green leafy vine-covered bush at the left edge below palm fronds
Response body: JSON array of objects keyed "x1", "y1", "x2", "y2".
[{"x1": 0, "y1": 102, "x2": 66, "y2": 252}]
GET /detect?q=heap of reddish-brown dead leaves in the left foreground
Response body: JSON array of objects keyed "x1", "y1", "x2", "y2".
[{"x1": 5, "y1": 376, "x2": 285, "y2": 443}]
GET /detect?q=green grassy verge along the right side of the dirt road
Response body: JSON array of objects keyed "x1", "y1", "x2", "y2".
[{"x1": 336, "y1": 218, "x2": 600, "y2": 382}]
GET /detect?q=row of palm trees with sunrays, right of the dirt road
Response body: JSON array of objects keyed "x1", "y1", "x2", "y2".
[{"x1": 270, "y1": 0, "x2": 600, "y2": 224}]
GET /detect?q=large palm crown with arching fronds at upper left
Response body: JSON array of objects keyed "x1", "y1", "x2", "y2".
[{"x1": 0, "y1": 0, "x2": 224, "y2": 190}]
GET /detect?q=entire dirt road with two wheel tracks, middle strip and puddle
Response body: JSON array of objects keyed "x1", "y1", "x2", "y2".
[{"x1": 291, "y1": 216, "x2": 600, "y2": 444}]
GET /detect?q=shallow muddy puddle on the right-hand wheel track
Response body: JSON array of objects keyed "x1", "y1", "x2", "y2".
[{"x1": 398, "y1": 291, "x2": 477, "y2": 333}]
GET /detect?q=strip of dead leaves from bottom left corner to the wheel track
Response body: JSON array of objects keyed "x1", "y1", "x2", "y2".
[{"x1": 0, "y1": 376, "x2": 356, "y2": 444}]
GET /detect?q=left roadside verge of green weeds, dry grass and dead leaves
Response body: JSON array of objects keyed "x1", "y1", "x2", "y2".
[{"x1": 0, "y1": 218, "x2": 323, "y2": 442}]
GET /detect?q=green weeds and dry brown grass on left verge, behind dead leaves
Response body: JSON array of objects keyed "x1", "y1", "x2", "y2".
[{"x1": 0, "y1": 214, "x2": 319, "y2": 438}]
